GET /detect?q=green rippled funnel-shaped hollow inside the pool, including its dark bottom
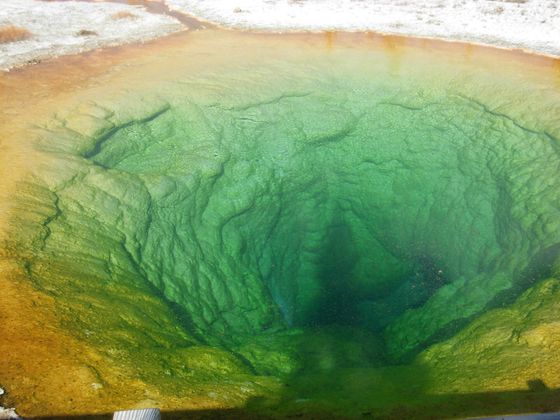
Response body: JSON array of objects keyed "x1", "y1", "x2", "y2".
[{"x1": 68, "y1": 97, "x2": 556, "y2": 368}]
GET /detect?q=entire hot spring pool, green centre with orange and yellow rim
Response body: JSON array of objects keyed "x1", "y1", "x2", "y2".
[{"x1": 0, "y1": 30, "x2": 560, "y2": 418}]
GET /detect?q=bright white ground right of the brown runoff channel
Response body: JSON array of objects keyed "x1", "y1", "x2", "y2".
[{"x1": 166, "y1": 0, "x2": 560, "y2": 56}]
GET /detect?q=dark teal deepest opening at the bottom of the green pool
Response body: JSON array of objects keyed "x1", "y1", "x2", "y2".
[{"x1": 260, "y1": 214, "x2": 449, "y2": 332}]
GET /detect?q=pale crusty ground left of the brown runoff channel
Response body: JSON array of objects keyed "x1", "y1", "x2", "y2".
[{"x1": 0, "y1": 0, "x2": 185, "y2": 70}]
